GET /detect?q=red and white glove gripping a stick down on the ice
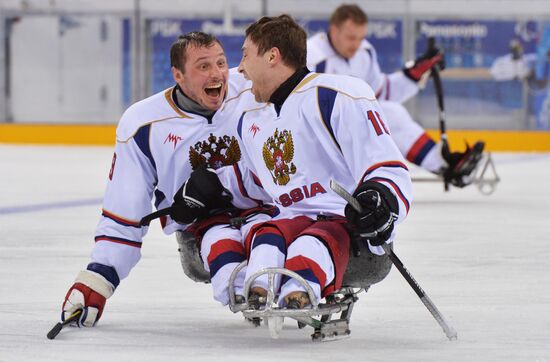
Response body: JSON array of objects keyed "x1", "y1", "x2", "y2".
[{"x1": 61, "y1": 270, "x2": 115, "y2": 327}]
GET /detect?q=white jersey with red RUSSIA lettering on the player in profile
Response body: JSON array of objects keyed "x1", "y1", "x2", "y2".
[{"x1": 218, "y1": 73, "x2": 412, "y2": 250}]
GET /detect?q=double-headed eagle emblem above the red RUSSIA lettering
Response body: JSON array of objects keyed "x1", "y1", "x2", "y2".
[{"x1": 262, "y1": 129, "x2": 296, "y2": 186}]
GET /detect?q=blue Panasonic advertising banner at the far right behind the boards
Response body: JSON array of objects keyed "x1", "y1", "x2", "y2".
[{"x1": 415, "y1": 19, "x2": 550, "y2": 129}]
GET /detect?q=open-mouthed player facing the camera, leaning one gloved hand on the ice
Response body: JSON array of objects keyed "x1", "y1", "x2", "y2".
[{"x1": 62, "y1": 32, "x2": 273, "y2": 327}]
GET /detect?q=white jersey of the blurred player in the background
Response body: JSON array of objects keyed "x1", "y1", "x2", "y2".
[{"x1": 307, "y1": 33, "x2": 418, "y2": 103}]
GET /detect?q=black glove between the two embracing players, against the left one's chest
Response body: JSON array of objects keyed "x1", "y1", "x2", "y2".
[{"x1": 170, "y1": 167, "x2": 232, "y2": 224}]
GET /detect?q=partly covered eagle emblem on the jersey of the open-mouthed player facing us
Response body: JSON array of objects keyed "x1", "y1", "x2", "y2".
[{"x1": 189, "y1": 133, "x2": 241, "y2": 170}]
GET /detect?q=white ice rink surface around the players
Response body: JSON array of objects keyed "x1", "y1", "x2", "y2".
[{"x1": 0, "y1": 145, "x2": 550, "y2": 362}]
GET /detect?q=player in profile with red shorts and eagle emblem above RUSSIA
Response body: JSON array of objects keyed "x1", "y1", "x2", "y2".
[{"x1": 174, "y1": 15, "x2": 411, "y2": 308}]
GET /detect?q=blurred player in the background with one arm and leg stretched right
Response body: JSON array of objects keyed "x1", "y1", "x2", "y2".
[{"x1": 307, "y1": 4, "x2": 484, "y2": 187}]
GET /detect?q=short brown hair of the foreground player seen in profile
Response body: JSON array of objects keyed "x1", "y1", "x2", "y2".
[{"x1": 246, "y1": 14, "x2": 307, "y2": 69}]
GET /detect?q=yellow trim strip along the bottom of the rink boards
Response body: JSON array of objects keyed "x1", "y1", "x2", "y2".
[{"x1": 0, "y1": 123, "x2": 550, "y2": 152}]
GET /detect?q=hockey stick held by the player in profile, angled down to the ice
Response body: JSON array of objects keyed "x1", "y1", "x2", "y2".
[{"x1": 330, "y1": 180, "x2": 458, "y2": 341}]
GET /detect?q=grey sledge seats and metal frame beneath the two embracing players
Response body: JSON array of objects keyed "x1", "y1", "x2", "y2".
[{"x1": 176, "y1": 226, "x2": 391, "y2": 341}]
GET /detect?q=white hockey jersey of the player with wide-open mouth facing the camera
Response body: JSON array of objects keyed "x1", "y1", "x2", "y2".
[{"x1": 92, "y1": 70, "x2": 265, "y2": 279}]
